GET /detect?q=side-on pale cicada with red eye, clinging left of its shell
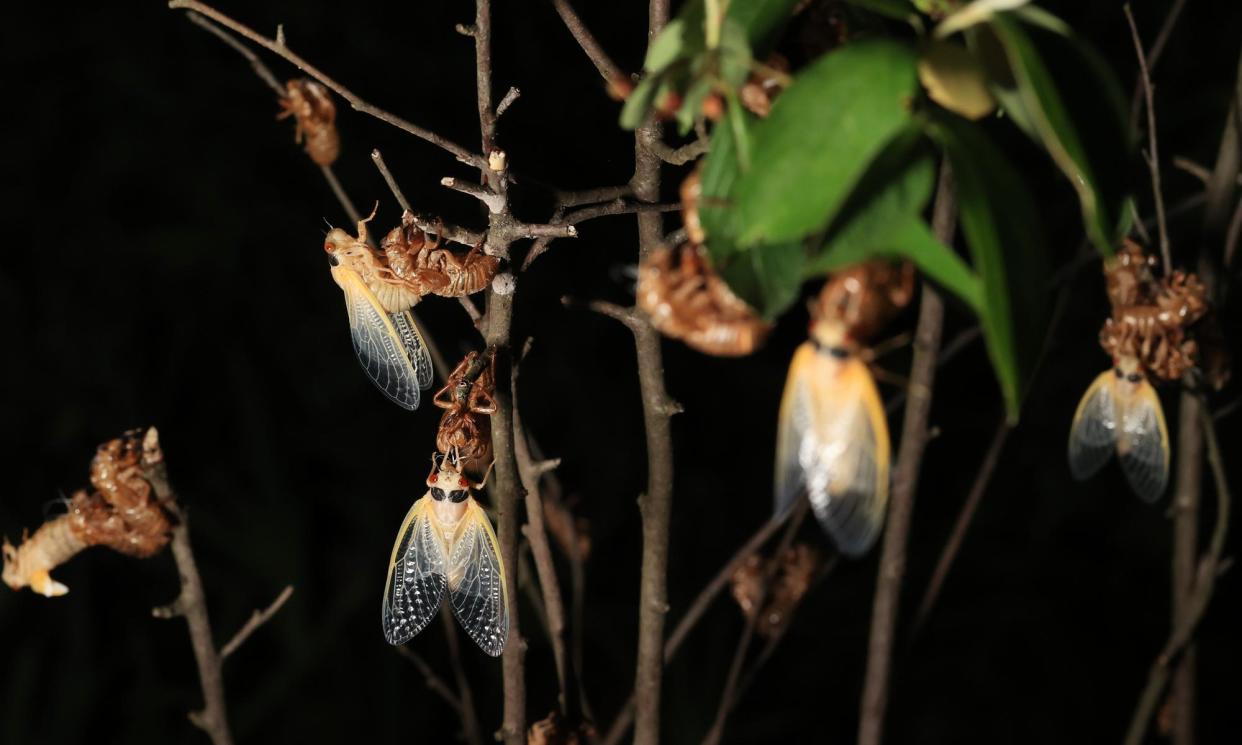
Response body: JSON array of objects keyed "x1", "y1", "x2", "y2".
[{"x1": 323, "y1": 212, "x2": 432, "y2": 411}]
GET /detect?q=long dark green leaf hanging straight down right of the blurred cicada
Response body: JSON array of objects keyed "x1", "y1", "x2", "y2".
[{"x1": 930, "y1": 115, "x2": 1048, "y2": 421}]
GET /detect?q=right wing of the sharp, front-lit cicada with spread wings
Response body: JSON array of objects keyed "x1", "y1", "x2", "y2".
[{"x1": 448, "y1": 498, "x2": 509, "y2": 657}]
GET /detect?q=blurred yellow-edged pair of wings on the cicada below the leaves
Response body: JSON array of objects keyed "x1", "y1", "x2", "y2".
[{"x1": 776, "y1": 344, "x2": 889, "y2": 556}]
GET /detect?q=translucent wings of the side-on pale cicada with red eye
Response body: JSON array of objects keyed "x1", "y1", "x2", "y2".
[{"x1": 332, "y1": 267, "x2": 431, "y2": 411}]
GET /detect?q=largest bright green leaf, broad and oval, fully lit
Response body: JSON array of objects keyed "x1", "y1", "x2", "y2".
[{"x1": 713, "y1": 40, "x2": 917, "y2": 247}]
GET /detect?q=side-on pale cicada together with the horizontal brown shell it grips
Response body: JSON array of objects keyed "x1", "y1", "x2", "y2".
[{"x1": 323, "y1": 212, "x2": 499, "y2": 411}]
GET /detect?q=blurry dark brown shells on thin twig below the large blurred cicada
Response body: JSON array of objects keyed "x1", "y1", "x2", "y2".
[{"x1": 732, "y1": 544, "x2": 823, "y2": 638}]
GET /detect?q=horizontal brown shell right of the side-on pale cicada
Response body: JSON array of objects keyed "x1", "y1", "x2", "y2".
[{"x1": 380, "y1": 212, "x2": 501, "y2": 298}]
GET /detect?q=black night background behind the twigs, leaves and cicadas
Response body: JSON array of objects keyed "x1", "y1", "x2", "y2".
[{"x1": 0, "y1": 1, "x2": 1242, "y2": 744}]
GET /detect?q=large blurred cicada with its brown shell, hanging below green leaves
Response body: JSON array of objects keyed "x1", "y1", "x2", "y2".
[{"x1": 775, "y1": 261, "x2": 914, "y2": 556}]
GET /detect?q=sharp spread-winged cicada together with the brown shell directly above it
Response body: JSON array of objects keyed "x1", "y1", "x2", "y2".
[{"x1": 383, "y1": 350, "x2": 509, "y2": 657}]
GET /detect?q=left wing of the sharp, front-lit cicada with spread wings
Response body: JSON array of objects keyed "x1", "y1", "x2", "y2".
[{"x1": 383, "y1": 497, "x2": 448, "y2": 644}]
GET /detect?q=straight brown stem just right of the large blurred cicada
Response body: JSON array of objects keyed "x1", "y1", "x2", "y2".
[{"x1": 858, "y1": 161, "x2": 958, "y2": 745}]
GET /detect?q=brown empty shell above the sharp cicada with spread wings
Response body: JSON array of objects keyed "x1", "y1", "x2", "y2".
[{"x1": 431, "y1": 351, "x2": 496, "y2": 474}]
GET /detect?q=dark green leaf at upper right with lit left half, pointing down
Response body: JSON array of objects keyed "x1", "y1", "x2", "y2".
[{"x1": 979, "y1": 9, "x2": 1130, "y2": 256}]
